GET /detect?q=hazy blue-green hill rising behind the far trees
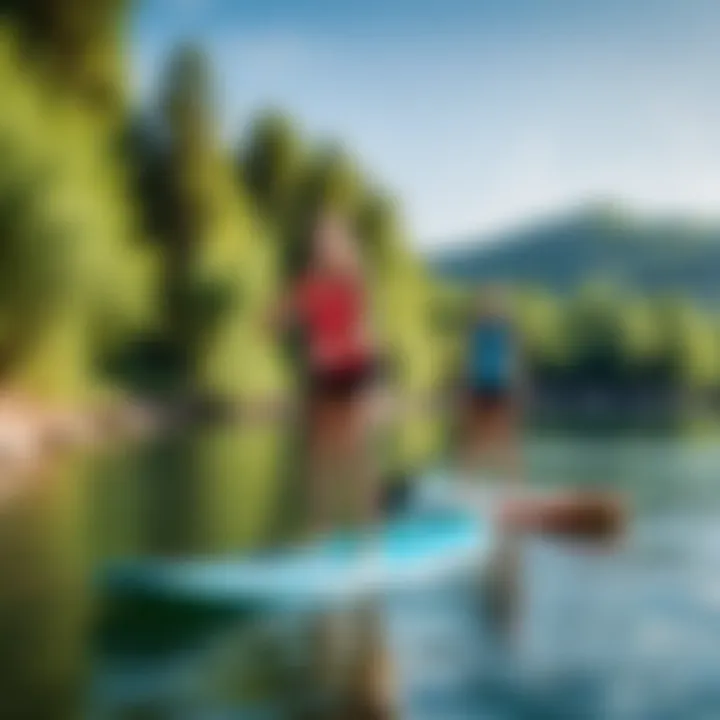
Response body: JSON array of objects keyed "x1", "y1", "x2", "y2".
[{"x1": 430, "y1": 208, "x2": 720, "y2": 304}]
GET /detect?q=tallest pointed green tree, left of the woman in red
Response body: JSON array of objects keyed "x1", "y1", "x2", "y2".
[{"x1": 150, "y1": 48, "x2": 282, "y2": 395}]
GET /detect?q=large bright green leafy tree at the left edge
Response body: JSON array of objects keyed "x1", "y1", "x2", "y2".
[{"x1": 0, "y1": 30, "x2": 152, "y2": 394}]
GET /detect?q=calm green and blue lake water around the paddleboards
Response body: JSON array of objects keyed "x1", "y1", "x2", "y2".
[{"x1": 0, "y1": 429, "x2": 720, "y2": 720}]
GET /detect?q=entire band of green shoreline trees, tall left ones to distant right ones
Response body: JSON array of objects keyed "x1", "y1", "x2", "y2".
[{"x1": 0, "y1": 0, "x2": 720, "y2": 434}]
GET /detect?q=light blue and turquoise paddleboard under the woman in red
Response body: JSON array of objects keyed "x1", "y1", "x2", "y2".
[{"x1": 104, "y1": 510, "x2": 491, "y2": 610}]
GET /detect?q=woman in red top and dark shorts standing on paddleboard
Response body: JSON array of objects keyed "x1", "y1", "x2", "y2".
[{"x1": 272, "y1": 214, "x2": 376, "y2": 529}]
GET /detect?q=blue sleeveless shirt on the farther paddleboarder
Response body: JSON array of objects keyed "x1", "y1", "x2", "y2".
[{"x1": 467, "y1": 319, "x2": 513, "y2": 389}]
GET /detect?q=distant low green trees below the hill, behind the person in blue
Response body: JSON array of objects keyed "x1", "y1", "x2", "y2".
[{"x1": 435, "y1": 281, "x2": 720, "y2": 414}]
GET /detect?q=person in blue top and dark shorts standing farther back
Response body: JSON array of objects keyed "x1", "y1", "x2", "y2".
[{"x1": 462, "y1": 289, "x2": 521, "y2": 475}]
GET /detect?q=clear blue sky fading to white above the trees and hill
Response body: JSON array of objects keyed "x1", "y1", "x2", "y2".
[{"x1": 132, "y1": 0, "x2": 720, "y2": 247}]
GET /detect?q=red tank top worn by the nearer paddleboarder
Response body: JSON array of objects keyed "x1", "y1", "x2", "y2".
[{"x1": 295, "y1": 275, "x2": 370, "y2": 370}]
